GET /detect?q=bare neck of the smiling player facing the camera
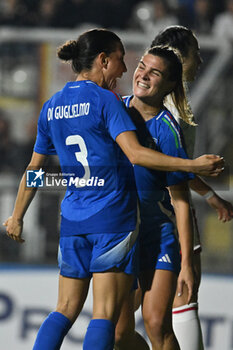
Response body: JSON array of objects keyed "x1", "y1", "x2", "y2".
[{"x1": 130, "y1": 96, "x2": 163, "y2": 121}]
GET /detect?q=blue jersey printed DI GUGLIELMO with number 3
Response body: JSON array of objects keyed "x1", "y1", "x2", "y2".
[{"x1": 34, "y1": 80, "x2": 136, "y2": 236}]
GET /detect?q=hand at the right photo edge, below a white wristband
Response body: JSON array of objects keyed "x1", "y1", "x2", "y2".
[{"x1": 207, "y1": 193, "x2": 233, "y2": 222}]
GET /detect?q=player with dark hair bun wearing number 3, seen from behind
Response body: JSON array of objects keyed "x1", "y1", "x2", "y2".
[{"x1": 5, "y1": 29, "x2": 223, "y2": 350}]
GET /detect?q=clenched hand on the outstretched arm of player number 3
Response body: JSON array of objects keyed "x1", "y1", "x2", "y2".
[{"x1": 193, "y1": 154, "x2": 224, "y2": 176}]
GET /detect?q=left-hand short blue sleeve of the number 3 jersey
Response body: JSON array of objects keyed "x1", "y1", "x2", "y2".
[{"x1": 34, "y1": 104, "x2": 57, "y2": 155}]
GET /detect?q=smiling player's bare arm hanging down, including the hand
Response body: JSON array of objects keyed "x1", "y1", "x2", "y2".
[{"x1": 169, "y1": 181, "x2": 194, "y2": 304}]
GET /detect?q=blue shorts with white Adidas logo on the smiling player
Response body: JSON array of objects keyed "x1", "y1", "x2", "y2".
[{"x1": 139, "y1": 224, "x2": 181, "y2": 275}]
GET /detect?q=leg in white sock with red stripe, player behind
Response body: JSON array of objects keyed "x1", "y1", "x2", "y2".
[{"x1": 173, "y1": 252, "x2": 204, "y2": 350}]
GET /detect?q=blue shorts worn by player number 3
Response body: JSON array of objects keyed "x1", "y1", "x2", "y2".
[{"x1": 58, "y1": 231, "x2": 138, "y2": 278}]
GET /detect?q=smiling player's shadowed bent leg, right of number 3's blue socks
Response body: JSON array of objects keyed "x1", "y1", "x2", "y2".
[{"x1": 114, "y1": 291, "x2": 149, "y2": 350}]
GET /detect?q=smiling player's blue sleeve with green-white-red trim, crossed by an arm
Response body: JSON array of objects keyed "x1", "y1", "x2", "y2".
[{"x1": 158, "y1": 114, "x2": 194, "y2": 186}]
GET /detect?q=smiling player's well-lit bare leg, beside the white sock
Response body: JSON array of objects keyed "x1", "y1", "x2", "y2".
[{"x1": 140, "y1": 270, "x2": 180, "y2": 350}]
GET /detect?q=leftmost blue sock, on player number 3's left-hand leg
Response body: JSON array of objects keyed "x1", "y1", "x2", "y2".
[{"x1": 33, "y1": 312, "x2": 72, "y2": 350}]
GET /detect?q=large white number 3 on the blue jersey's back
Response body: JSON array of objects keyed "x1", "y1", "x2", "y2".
[{"x1": 66, "y1": 135, "x2": 90, "y2": 187}]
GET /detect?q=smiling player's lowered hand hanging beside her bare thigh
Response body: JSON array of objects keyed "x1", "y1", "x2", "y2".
[{"x1": 177, "y1": 266, "x2": 195, "y2": 304}]
